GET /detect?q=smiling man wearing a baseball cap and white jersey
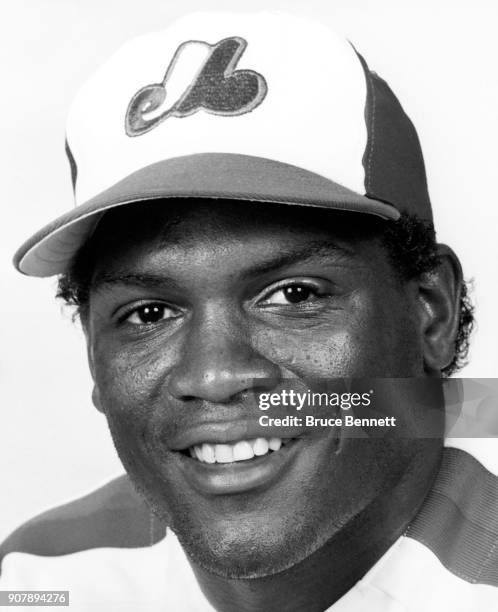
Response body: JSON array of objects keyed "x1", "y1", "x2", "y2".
[{"x1": 0, "y1": 14, "x2": 498, "y2": 611}]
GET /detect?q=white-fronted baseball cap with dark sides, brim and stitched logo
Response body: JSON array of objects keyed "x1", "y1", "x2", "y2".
[{"x1": 14, "y1": 12, "x2": 432, "y2": 276}]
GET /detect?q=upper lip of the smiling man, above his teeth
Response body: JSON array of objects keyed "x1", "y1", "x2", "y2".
[{"x1": 168, "y1": 420, "x2": 304, "y2": 451}]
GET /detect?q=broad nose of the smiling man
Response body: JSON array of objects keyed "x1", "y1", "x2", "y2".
[{"x1": 168, "y1": 319, "x2": 280, "y2": 403}]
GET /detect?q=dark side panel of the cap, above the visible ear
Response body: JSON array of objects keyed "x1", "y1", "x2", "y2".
[{"x1": 358, "y1": 54, "x2": 432, "y2": 220}]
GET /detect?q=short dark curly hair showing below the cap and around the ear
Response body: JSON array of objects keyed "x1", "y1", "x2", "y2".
[{"x1": 57, "y1": 207, "x2": 474, "y2": 377}]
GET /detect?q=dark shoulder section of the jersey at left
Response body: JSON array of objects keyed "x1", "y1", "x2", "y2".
[{"x1": 0, "y1": 475, "x2": 166, "y2": 563}]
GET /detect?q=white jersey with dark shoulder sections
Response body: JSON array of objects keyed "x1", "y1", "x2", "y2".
[{"x1": 0, "y1": 442, "x2": 498, "y2": 612}]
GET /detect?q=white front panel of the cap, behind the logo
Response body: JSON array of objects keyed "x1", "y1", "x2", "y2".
[{"x1": 67, "y1": 13, "x2": 367, "y2": 204}]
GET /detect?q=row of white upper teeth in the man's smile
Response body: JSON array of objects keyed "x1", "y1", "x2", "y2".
[{"x1": 189, "y1": 438, "x2": 288, "y2": 463}]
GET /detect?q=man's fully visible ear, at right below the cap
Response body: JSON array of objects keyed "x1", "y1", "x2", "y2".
[{"x1": 419, "y1": 244, "x2": 463, "y2": 376}]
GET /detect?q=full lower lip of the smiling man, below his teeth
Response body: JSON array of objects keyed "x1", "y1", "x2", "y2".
[{"x1": 178, "y1": 440, "x2": 302, "y2": 495}]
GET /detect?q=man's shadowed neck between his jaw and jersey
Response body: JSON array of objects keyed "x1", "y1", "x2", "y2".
[{"x1": 192, "y1": 443, "x2": 441, "y2": 612}]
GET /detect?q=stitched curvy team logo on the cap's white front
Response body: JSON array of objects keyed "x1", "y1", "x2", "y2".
[{"x1": 125, "y1": 36, "x2": 268, "y2": 136}]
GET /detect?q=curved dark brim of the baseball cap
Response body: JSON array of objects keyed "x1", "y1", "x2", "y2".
[{"x1": 14, "y1": 153, "x2": 399, "y2": 276}]
